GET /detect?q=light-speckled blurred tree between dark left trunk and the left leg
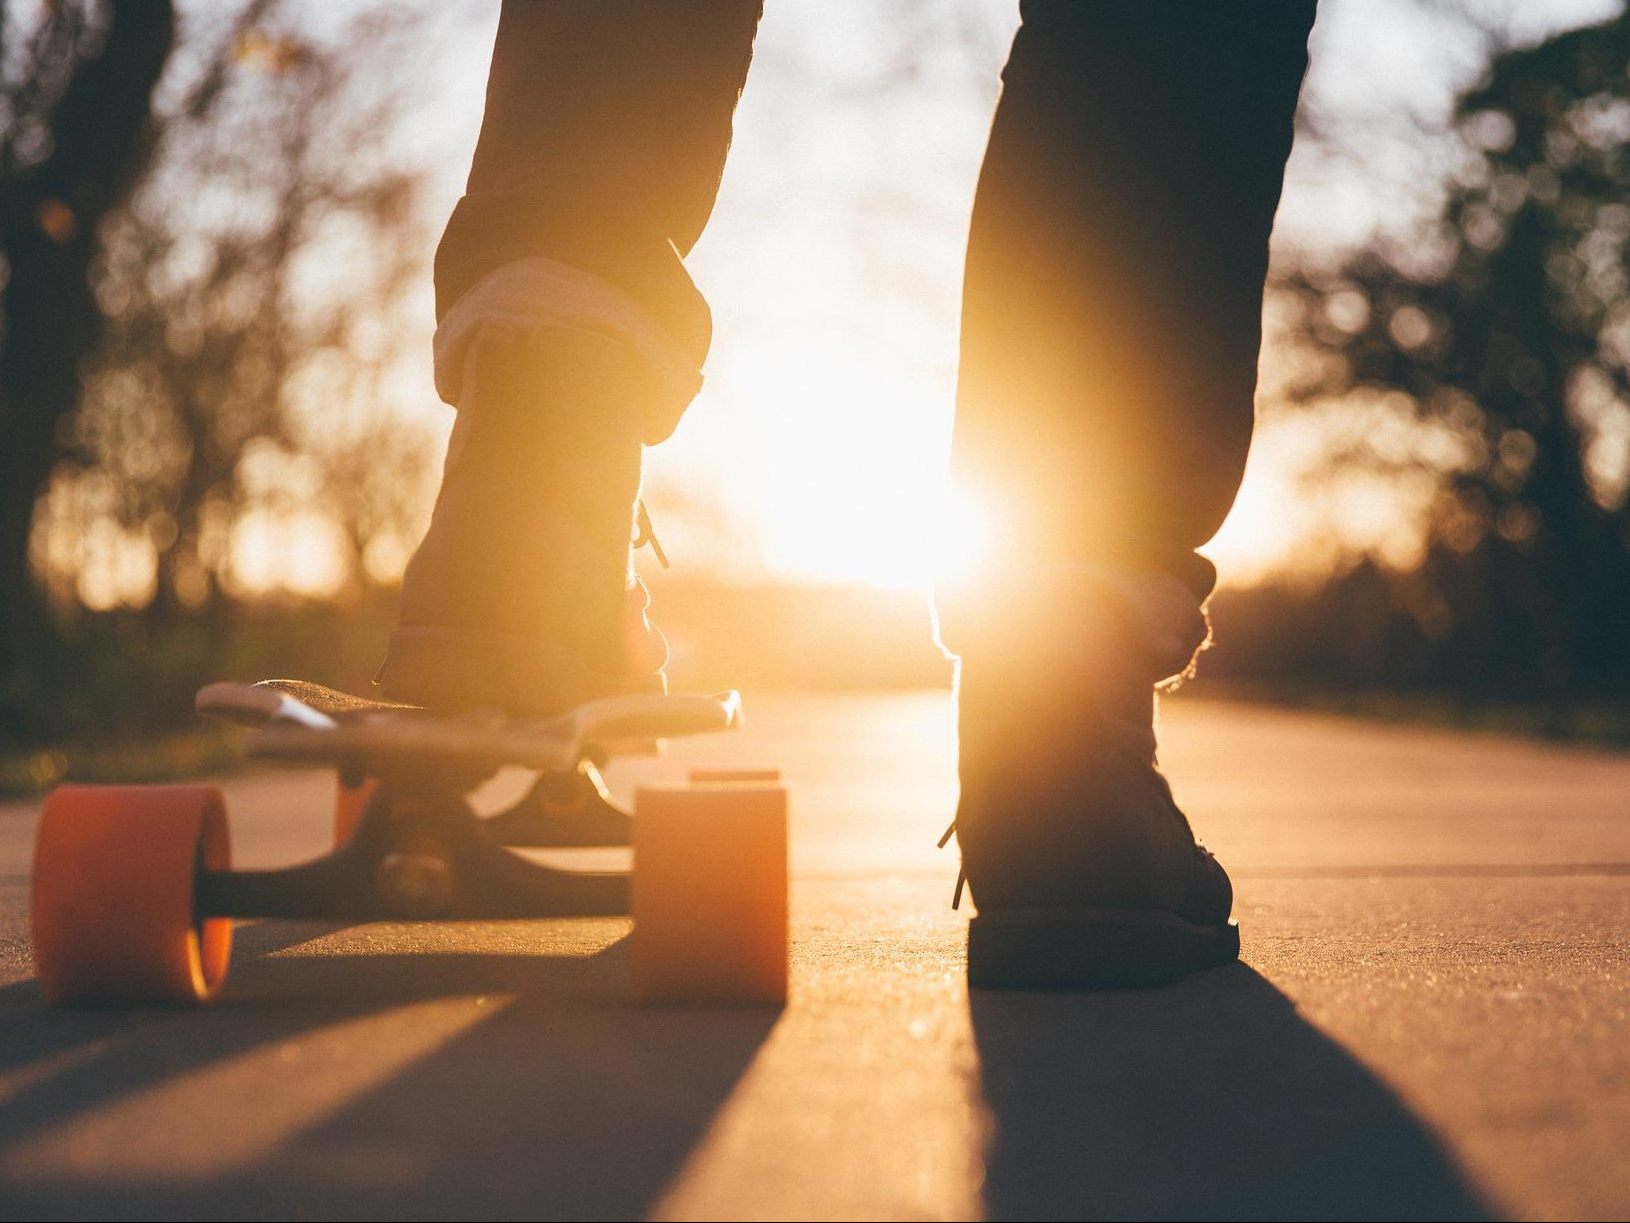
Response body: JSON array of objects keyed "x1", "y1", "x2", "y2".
[{"x1": 46, "y1": 7, "x2": 427, "y2": 618}]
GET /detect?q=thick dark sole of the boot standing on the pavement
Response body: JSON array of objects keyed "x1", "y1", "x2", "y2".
[{"x1": 968, "y1": 908, "x2": 1239, "y2": 990}]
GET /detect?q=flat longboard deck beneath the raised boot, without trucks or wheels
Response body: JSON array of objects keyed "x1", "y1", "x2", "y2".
[{"x1": 196, "y1": 680, "x2": 742, "y2": 773}]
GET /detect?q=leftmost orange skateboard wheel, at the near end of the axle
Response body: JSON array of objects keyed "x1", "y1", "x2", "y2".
[{"x1": 31, "y1": 786, "x2": 231, "y2": 1003}]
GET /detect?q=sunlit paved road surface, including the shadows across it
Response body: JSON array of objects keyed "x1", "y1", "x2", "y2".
[{"x1": 0, "y1": 693, "x2": 1630, "y2": 1220}]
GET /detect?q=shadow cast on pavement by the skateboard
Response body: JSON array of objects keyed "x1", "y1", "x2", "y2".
[{"x1": 0, "y1": 923, "x2": 779, "y2": 1218}]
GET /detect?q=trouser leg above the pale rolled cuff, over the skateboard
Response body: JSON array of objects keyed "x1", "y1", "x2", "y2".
[{"x1": 435, "y1": 0, "x2": 763, "y2": 440}]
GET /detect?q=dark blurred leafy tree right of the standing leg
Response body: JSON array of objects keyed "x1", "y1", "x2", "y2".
[{"x1": 1280, "y1": 15, "x2": 1630, "y2": 691}]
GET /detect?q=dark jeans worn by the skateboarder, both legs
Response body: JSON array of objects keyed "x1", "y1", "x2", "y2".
[{"x1": 435, "y1": 0, "x2": 1314, "y2": 598}]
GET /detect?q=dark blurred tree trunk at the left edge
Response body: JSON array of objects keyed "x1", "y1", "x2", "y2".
[{"x1": 0, "y1": 0, "x2": 174, "y2": 697}]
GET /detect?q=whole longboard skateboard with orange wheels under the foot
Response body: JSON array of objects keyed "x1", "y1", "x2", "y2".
[{"x1": 31, "y1": 680, "x2": 786, "y2": 1003}]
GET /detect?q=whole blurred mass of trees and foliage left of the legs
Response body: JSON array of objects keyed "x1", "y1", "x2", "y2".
[{"x1": 0, "y1": 0, "x2": 432, "y2": 744}]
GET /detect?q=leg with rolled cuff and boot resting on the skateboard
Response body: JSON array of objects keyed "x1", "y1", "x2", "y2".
[{"x1": 380, "y1": 0, "x2": 761, "y2": 713}]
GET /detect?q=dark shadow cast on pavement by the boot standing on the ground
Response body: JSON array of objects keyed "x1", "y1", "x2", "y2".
[{"x1": 970, "y1": 964, "x2": 1498, "y2": 1220}]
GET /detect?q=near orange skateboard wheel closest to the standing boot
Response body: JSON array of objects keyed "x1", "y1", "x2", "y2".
[{"x1": 632, "y1": 773, "x2": 787, "y2": 1003}]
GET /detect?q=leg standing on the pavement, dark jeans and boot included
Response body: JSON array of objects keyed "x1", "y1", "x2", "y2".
[{"x1": 937, "y1": 0, "x2": 1314, "y2": 983}]
